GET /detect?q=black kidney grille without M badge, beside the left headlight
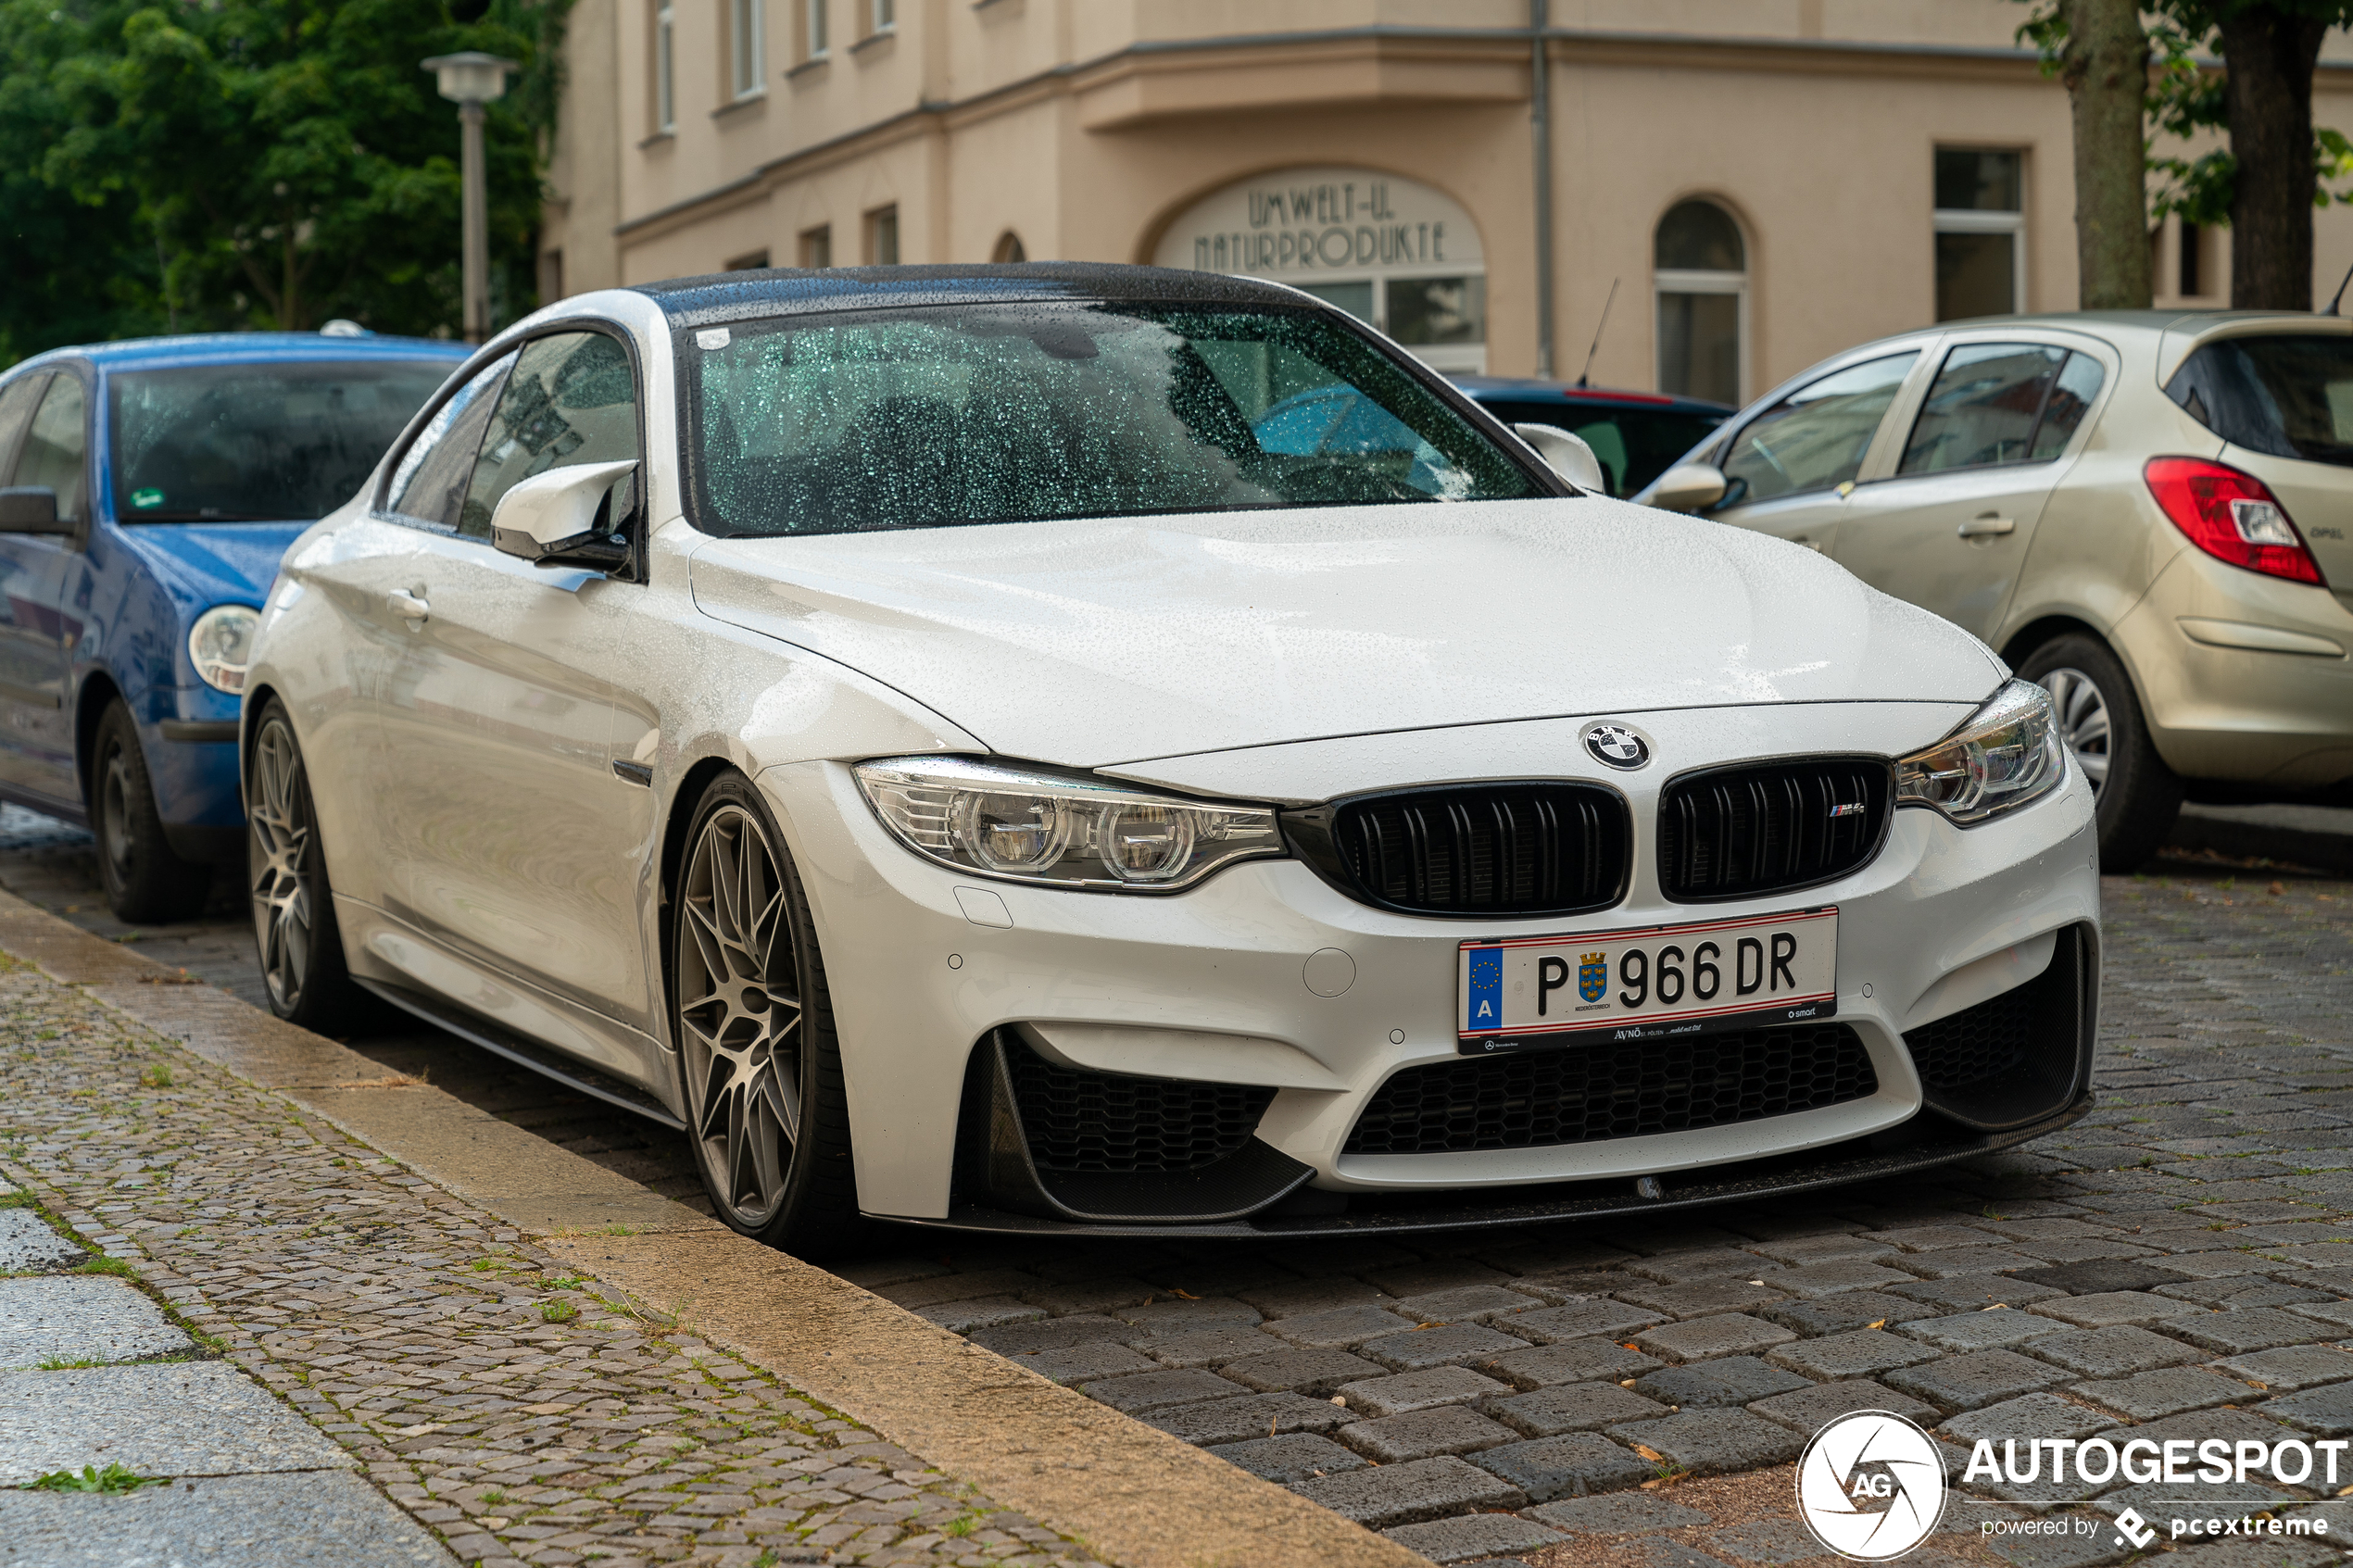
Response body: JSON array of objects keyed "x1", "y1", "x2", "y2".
[{"x1": 1332, "y1": 783, "x2": 1633, "y2": 914}]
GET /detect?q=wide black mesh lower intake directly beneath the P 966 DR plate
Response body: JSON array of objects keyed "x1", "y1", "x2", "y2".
[{"x1": 1346, "y1": 1022, "x2": 1880, "y2": 1154}]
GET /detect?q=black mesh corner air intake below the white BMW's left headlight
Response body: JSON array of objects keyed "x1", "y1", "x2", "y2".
[{"x1": 1005, "y1": 1039, "x2": 1276, "y2": 1171}]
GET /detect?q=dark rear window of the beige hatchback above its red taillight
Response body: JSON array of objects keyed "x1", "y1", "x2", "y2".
[{"x1": 2165, "y1": 333, "x2": 2353, "y2": 468}]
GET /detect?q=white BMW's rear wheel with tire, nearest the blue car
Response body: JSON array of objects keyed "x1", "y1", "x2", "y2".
[{"x1": 245, "y1": 698, "x2": 367, "y2": 1032}]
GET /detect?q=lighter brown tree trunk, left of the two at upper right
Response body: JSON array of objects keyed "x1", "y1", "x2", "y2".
[{"x1": 2059, "y1": 0, "x2": 2151, "y2": 310}]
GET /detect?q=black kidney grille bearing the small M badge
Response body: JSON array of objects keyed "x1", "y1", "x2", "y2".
[{"x1": 1659, "y1": 757, "x2": 1892, "y2": 903}]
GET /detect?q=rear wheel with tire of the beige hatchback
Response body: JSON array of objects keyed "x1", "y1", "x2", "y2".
[{"x1": 2019, "y1": 633, "x2": 2182, "y2": 877}]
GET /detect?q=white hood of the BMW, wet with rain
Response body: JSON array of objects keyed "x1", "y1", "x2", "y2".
[{"x1": 692, "y1": 496, "x2": 2000, "y2": 766}]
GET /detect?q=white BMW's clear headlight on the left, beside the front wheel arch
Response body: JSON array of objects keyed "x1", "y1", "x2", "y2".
[{"x1": 854, "y1": 757, "x2": 1285, "y2": 894}]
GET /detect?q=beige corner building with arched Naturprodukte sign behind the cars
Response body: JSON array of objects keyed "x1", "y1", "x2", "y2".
[{"x1": 541, "y1": 0, "x2": 2353, "y2": 402}]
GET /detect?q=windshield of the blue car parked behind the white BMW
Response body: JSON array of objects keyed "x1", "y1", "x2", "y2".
[{"x1": 108, "y1": 359, "x2": 449, "y2": 521}]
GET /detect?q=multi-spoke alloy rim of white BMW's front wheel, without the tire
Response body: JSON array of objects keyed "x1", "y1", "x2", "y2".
[{"x1": 678, "y1": 807, "x2": 800, "y2": 1229}]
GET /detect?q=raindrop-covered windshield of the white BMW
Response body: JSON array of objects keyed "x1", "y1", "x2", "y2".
[{"x1": 680, "y1": 306, "x2": 1553, "y2": 533}]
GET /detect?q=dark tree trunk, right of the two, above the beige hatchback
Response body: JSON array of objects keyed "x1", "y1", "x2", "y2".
[{"x1": 2219, "y1": 5, "x2": 2327, "y2": 310}]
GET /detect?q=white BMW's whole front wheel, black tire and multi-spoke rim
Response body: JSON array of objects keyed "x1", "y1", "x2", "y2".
[{"x1": 671, "y1": 773, "x2": 866, "y2": 1258}]
